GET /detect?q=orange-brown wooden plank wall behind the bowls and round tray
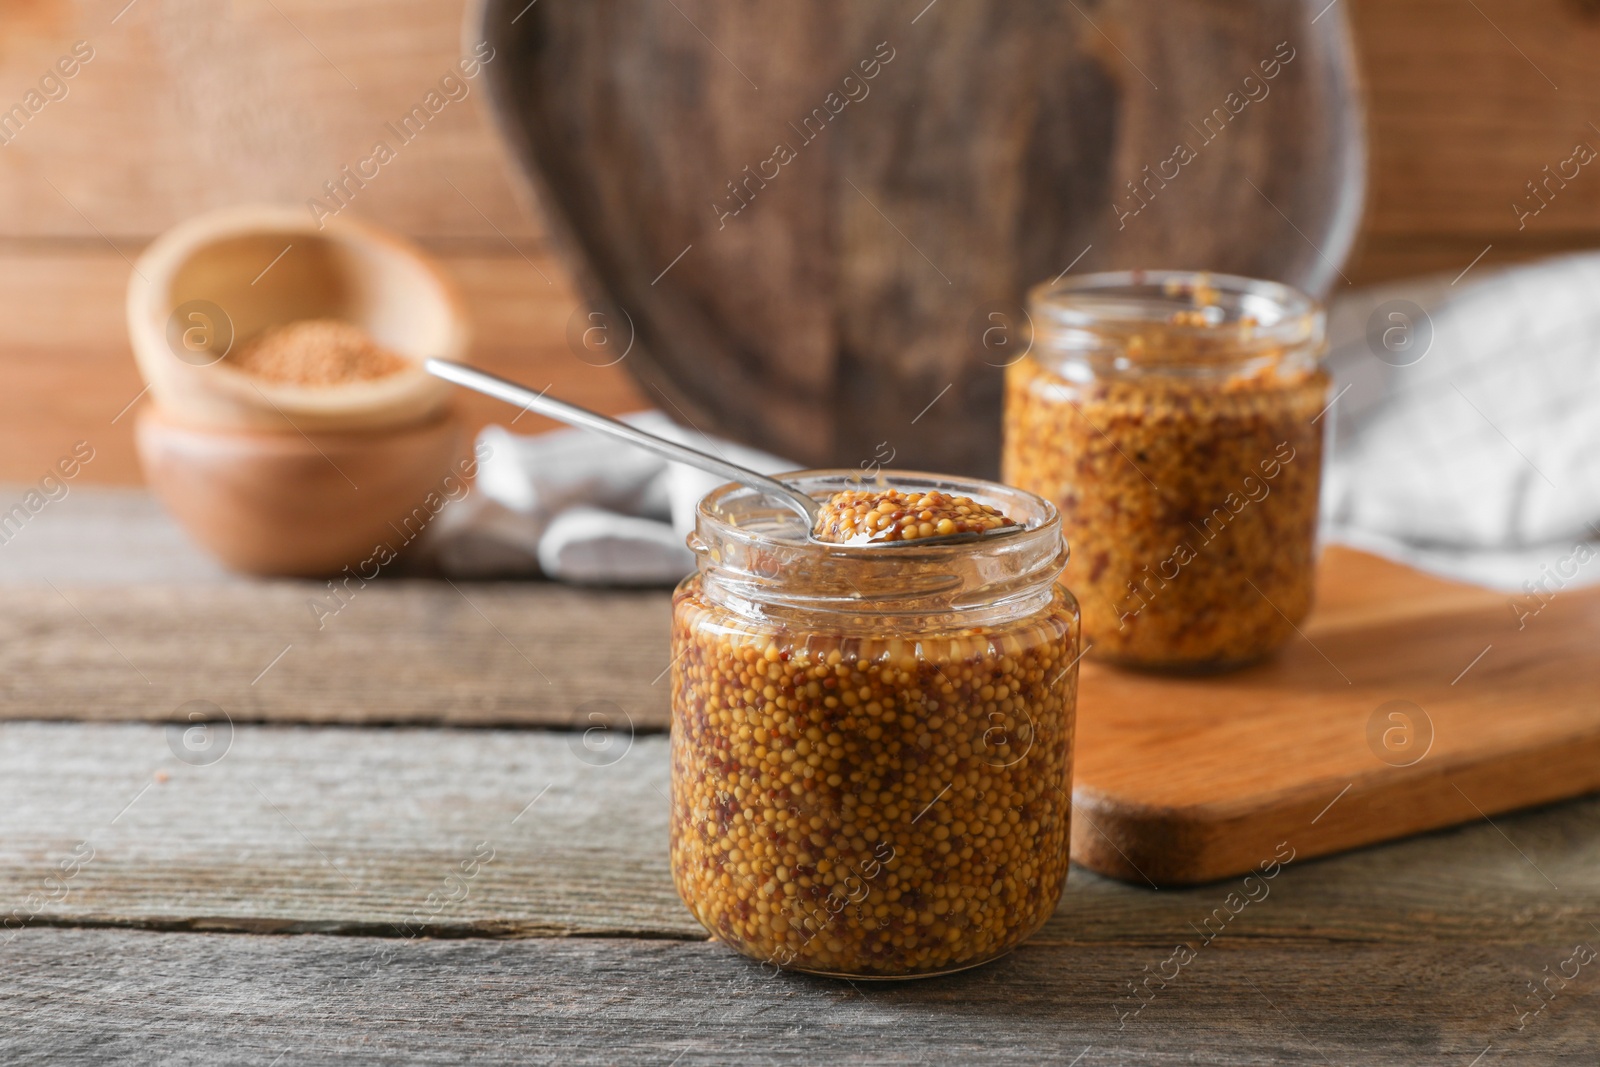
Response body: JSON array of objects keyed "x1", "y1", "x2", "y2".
[{"x1": 0, "y1": 0, "x2": 1600, "y2": 483}]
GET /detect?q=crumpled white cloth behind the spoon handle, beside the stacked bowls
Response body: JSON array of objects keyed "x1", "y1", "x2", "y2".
[{"x1": 430, "y1": 411, "x2": 795, "y2": 585}]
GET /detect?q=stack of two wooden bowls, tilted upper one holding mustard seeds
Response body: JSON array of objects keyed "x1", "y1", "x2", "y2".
[{"x1": 128, "y1": 208, "x2": 470, "y2": 577}]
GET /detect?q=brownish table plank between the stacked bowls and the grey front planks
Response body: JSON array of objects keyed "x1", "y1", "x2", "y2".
[{"x1": 0, "y1": 585, "x2": 669, "y2": 729}]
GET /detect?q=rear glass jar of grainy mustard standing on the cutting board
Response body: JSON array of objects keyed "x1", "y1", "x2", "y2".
[{"x1": 1002, "y1": 270, "x2": 1328, "y2": 670}]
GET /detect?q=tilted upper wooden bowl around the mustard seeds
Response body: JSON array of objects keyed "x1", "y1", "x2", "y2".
[{"x1": 128, "y1": 206, "x2": 469, "y2": 432}]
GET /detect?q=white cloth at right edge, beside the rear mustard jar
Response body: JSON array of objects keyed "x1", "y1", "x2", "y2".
[{"x1": 1323, "y1": 253, "x2": 1600, "y2": 595}]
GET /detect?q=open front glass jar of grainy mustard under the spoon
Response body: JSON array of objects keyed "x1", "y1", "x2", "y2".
[{"x1": 672, "y1": 472, "x2": 1078, "y2": 977}]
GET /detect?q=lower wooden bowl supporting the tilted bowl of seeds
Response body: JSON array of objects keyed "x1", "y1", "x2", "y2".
[{"x1": 136, "y1": 405, "x2": 464, "y2": 579}]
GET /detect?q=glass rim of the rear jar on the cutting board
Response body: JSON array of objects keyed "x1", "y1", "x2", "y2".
[{"x1": 1029, "y1": 270, "x2": 1325, "y2": 347}]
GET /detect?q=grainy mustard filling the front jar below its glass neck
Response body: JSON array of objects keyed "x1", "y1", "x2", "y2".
[{"x1": 670, "y1": 579, "x2": 1078, "y2": 977}]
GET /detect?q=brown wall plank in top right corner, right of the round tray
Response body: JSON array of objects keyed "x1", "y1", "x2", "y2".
[{"x1": 1352, "y1": 0, "x2": 1600, "y2": 237}]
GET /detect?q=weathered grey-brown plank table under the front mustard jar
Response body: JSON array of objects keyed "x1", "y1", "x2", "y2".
[{"x1": 0, "y1": 490, "x2": 1600, "y2": 1067}]
